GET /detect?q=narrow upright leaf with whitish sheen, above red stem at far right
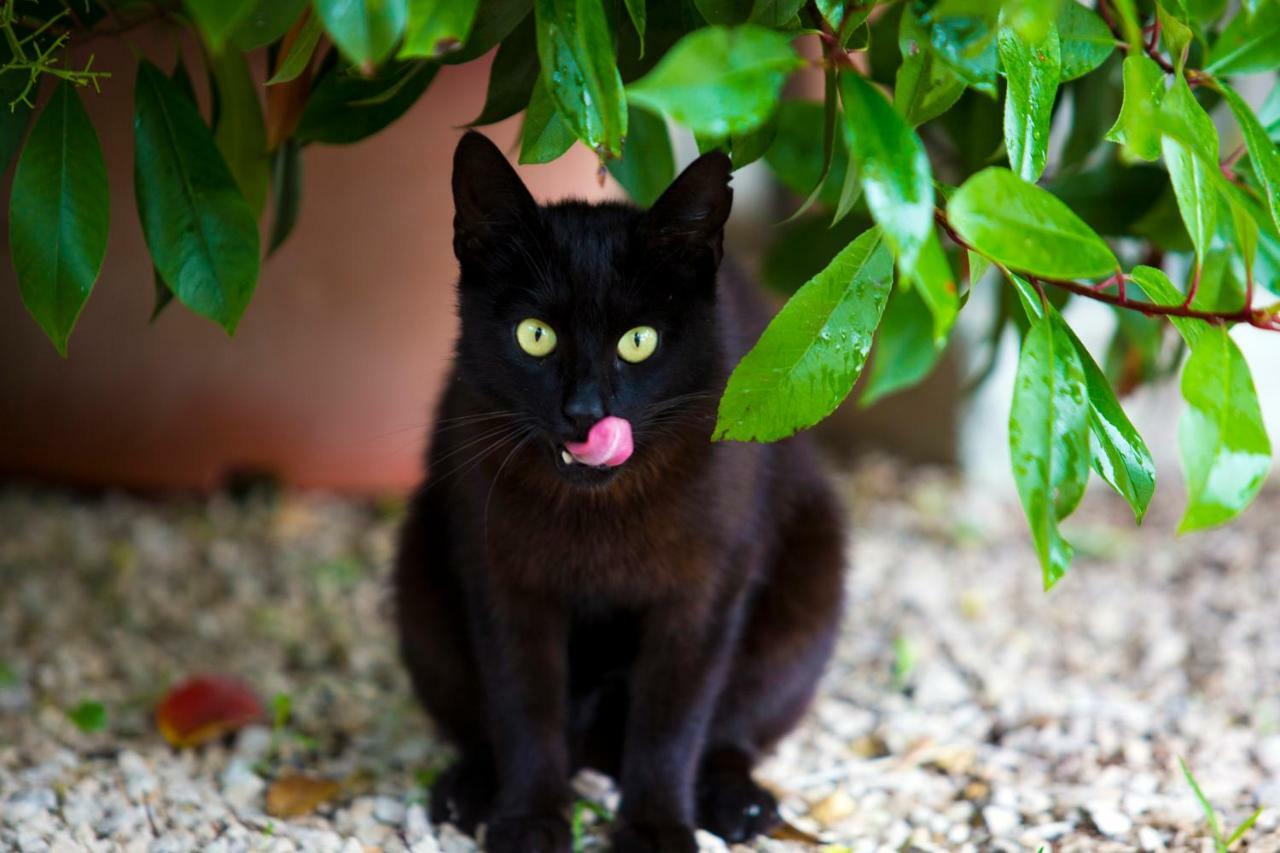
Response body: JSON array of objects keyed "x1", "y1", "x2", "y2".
[{"x1": 1160, "y1": 78, "x2": 1219, "y2": 263}]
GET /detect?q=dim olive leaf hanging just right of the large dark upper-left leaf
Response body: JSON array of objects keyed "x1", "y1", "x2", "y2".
[{"x1": 210, "y1": 50, "x2": 271, "y2": 215}]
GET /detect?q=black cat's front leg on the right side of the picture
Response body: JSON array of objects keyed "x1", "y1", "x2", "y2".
[{"x1": 613, "y1": 591, "x2": 739, "y2": 853}]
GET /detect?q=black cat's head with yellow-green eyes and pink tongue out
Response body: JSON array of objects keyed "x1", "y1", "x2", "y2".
[{"x1": 453, "y1": 132, "x2": 732, "y2": 484}]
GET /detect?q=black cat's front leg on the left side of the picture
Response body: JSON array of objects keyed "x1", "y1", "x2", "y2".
[{"x1": 476, "y1": 590, "x2": 571, "y2": 853}]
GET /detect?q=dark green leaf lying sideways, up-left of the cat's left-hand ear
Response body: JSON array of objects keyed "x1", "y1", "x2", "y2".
[{"x1": 294, "y1": 60, "x2": 440, "y2": 145}]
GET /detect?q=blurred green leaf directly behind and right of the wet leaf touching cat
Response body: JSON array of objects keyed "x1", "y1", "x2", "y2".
[{"x1": 858, "y1": 281, "x2": 942, "y2": 407}]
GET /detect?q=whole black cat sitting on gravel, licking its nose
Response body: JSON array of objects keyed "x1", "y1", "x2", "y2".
[{"x1": 396, "y1": 133, "x2": 844, "y2": 853}]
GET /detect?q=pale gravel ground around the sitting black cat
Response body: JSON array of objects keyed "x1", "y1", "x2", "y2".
[{"x1": 0, "y1": 461, "x2": 1280, "y2": 853}]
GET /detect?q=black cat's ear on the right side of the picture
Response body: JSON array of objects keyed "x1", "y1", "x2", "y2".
[{"x1": 643, "y1": 151, "x2": 733, "y2": 266}]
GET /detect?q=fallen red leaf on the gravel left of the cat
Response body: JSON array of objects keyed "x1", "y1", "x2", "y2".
[{"x1": 155, "y1": 675, "x2": 266, "y2": 747}]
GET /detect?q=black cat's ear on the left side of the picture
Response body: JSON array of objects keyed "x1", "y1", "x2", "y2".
[{"x1": 453, "y1": 131, "x2": 538, "y2": 260}]
